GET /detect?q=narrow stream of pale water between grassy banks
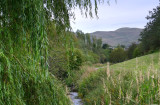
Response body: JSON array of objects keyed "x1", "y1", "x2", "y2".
[{"x1": 70, "y1": 92, "x2": 83, "y2": 105}]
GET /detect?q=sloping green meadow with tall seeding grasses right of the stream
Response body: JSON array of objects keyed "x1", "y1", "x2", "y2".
[{"x1": 78, "y1": 52, "x2": 160, "y2": 105}]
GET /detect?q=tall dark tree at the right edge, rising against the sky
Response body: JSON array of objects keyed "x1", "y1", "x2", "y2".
[{"x1": 140, "y1": 6, "x2": 160, "y2": 53}]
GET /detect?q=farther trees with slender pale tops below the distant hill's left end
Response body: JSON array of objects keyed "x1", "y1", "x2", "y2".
[{"x1": 76, "y1": 30, "x2": 111, "y2": 63}]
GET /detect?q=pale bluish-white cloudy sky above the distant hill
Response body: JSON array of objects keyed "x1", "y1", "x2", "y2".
[{"x1": 70, "y1": 0, "x2": 159, "y2": 33}]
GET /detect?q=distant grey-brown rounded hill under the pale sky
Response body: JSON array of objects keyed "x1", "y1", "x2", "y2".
[{"x1": 90, "y1": 27, "x2": 143, "y2": 46}]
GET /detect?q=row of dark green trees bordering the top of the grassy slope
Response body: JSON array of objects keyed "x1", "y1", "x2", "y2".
[{"x1": 90, "y1": 6, "x2": 160, "y2": 63}]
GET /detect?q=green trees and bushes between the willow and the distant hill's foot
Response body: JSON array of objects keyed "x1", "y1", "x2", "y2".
[{"x1": 48, "y1": 27, "x2": 111, "y2": 80}]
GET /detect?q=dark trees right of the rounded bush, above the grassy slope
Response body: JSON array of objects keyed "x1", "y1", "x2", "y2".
[{"x1": 123, "y1": 6, "x2": 160, "y2": 59}]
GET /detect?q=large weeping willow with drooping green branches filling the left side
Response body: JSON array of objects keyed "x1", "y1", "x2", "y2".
[{"x1": 0, "y1": 0, "x2": 105, "y2": 105}]
